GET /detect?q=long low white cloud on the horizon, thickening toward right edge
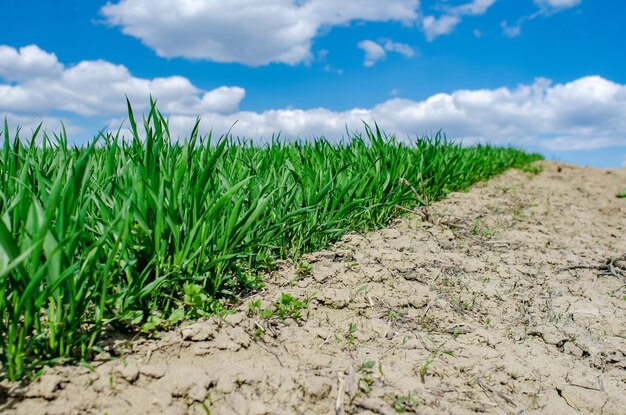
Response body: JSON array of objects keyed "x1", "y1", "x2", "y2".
[{"x1": 154, "y1": 76, "x2": 626, "y2": 154}]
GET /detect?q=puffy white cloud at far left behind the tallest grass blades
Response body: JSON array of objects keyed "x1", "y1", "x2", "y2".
[{"x1": 0, "y1": 45, "x2": 245, "y2": 116}]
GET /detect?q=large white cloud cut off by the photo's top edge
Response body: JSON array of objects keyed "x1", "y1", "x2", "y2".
[{"x1": 101, "y1": 0, "x2": 419, "y2": 66}]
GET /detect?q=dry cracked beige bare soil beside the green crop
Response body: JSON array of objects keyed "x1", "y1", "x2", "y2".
[{"x1": 0, "y1": 162, "x2": 626, "y2": 415}]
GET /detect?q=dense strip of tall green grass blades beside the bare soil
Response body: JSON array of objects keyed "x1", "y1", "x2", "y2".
[{"x1": 0, "y1": 102, "x2": 539, "y2": 380}]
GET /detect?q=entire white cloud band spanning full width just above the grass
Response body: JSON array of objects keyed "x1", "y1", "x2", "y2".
[{"x1": 0, "y1": 41, "x2": 626, "y2": 154}]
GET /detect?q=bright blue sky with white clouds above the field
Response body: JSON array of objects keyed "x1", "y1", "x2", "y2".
[{"x1": 0, "y1": 0, "x2": 626, "y2": 167}]
